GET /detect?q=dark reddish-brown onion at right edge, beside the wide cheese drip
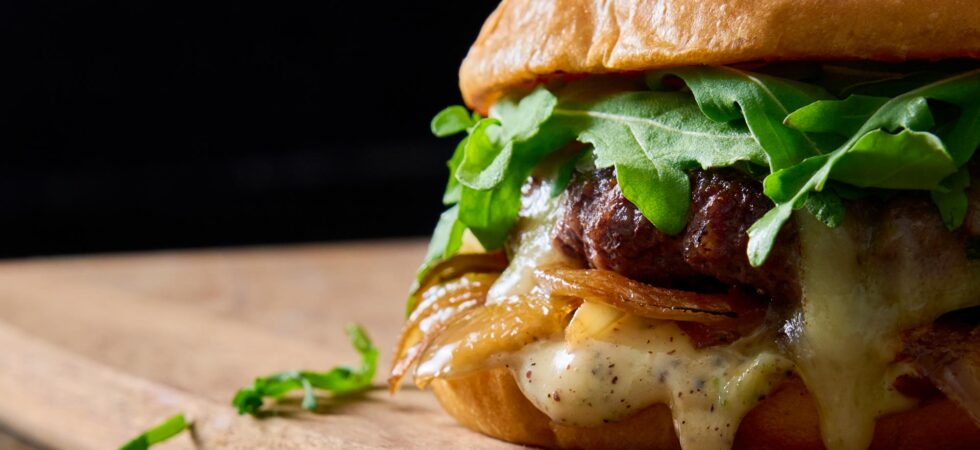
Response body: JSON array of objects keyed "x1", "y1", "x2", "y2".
[{"x1": 903, "y1": 322, "x2": 980, "y2": 426}]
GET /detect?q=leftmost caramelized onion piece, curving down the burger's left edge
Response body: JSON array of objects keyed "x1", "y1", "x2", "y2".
[{"x1": 388, "y1": 274, "x2": 498, "y2": 393}]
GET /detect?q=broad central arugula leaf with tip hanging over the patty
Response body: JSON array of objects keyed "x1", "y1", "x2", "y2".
[{"x1": 554, "y1": 92, "x2": 766, "y2": 234}]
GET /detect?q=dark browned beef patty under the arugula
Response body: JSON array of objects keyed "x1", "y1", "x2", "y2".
[{"x1": 554, "y1": 169, "x2": 980, "y2": 300}]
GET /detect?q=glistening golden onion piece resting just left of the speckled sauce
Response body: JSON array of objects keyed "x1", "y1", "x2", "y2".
[{"x1": 415, "y1": 294, "x2": 578, "y2": 387}]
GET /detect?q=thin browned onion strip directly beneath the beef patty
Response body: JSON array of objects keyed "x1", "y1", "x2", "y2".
[{"x1": 534, "y1": 269, "x2": 738, "y2": 324}]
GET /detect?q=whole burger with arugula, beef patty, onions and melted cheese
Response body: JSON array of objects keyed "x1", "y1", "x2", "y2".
[{"x1": 390, "y1": 0, "x2": 980, "y2": 450}]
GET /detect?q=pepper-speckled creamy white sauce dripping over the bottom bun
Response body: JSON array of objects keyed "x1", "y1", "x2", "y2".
[{"x1": 510, "y1": 316, "x2": 792, "y2": 450}]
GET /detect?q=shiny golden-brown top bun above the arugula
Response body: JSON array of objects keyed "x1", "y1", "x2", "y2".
[{"x1": 459, "y1": 0, "x2": 980, "y2": 112}]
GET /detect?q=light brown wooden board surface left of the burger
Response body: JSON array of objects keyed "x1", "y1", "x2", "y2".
[{"x1": 0, "y1": 241, "x2": 515, "y2": 450}]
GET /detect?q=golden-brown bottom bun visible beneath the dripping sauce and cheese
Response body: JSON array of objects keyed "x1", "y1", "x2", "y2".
[{"x1": 432, "y1": 369, "x2": 980, "y2": 450}]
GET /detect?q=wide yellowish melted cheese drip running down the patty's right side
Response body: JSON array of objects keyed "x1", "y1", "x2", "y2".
[{"x1": 784, "y1": 214, "x2": 980, "y2": 450}]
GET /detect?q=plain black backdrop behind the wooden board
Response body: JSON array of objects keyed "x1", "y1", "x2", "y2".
[{"x1": 0, "y1": 0, "x2": 495, "y2": 256}]
